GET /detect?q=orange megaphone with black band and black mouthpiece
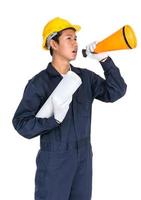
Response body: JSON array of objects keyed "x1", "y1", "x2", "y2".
[{"x1": 82, "y1": 25, "x2": 137, "y2": 57}]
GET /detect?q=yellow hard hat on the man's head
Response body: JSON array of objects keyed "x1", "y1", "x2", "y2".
[{"x1": 42, "y1": 17, "x2": 81, "y2": 50}]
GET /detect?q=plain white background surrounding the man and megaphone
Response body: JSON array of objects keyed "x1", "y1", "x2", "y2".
[{"x1": 0, "y1": 0, "x2": 141, "y2": 200}]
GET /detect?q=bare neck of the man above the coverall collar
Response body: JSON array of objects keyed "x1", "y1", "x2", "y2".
[{"x1": 52, "y1": 56, "x2": 70, "y2": 74}]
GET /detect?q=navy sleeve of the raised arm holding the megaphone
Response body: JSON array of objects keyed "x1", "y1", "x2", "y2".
[{"x1": 91, "y1": 57, "x2": 127, "y2": 102}]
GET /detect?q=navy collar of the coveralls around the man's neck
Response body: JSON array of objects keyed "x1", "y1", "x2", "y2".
[{"x1": 46, "y1": 63, "x2": 80, "y2": 76}]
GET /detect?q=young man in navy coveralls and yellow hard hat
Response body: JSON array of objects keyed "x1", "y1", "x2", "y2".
[{"x1": 13, "y1": 17, "x2": 126, "y2": 200}]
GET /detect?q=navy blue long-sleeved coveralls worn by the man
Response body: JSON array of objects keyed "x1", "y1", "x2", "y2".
[{"x1": 13, "y1": 57, "x2": 126, "y2": 200}]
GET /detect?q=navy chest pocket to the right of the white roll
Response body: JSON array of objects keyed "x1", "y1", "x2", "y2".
[{"x1": 76, "y1": 87, "x2": 92, "y2": 117}]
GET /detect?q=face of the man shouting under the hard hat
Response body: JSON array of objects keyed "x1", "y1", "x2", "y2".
[{"x1": 54, "y1": 29, "x2": 78, "y2": 61}]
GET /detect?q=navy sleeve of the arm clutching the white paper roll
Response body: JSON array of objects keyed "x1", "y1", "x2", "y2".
[{"x1": 12, "y1": 82, "x2": 59, "y2": 139}]
